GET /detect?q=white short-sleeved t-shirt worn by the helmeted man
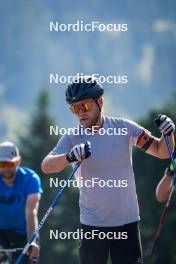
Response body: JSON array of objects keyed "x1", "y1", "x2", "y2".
[{"x1": 51, "y1": 116, "x2": 144, "y2": 227}]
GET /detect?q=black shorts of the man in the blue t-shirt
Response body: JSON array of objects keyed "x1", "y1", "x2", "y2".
[{"x1": 0, "y1": 230, "x2": 30, "y2": 264}]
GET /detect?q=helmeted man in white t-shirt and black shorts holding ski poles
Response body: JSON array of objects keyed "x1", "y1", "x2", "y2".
[{"x1": 42, "y1": 76, "x2": 175, "y2": 264}]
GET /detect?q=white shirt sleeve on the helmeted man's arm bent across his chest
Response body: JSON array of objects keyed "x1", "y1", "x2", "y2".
[{"x1": 51, "y1": 135, "x2": 73, "y2": 155}]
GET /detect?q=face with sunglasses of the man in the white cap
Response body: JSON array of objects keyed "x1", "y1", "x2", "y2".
[{"x1": 0, "y1": 161, "x2": 16, "y2": 179}]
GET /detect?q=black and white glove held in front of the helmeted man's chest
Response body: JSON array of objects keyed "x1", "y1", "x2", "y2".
[{"x1": 66, "y1": 141, "x2": 91, "y2": 162}]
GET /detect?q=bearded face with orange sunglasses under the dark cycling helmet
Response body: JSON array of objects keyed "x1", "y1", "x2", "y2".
[{"x1": 71, "y1": 99, "x2": 100, "y2": 128}]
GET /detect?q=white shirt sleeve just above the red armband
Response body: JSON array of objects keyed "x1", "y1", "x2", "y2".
[{"x1": 125, "y1": 119, "x2": 145, "y2": 145}]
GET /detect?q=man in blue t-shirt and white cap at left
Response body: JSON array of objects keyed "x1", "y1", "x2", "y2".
[{"x1": 0, "y1": 141, "x2": 42, "y2": 264}]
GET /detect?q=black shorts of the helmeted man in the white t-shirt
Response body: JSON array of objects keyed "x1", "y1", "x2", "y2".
[{"x1": 79, "y1": 222, "x2": 143, "y2": 264}]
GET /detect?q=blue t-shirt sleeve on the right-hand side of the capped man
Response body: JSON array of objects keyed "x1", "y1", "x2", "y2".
[{"x1": 25, "y1": 172, "x2": 43, "y2": 196}]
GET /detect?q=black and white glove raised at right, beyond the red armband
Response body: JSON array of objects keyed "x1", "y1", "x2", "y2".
[{"x1": 155, "y1": 115, "x2": 175, "y2": 136}]
